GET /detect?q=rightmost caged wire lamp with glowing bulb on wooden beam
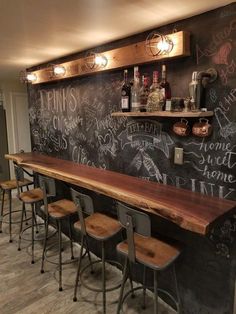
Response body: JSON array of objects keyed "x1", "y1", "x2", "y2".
[{"x1": 146, "y1": 32, "x2": 174, "y2": 56}]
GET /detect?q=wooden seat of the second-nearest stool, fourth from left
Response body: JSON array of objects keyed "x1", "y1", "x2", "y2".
[{"x1": 74, "y1": 212, "x2": 121, "y2": 240}]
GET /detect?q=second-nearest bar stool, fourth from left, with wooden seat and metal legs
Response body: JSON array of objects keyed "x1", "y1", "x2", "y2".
[{"x1": 71, "y1": 189, "x2": 122, "y2": 314}]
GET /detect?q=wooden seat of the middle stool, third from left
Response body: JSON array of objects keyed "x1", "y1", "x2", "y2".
[{"x1": 48, "y1": 199, "x2": 77, "y2": 219}]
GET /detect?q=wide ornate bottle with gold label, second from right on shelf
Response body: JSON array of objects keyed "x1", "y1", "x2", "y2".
[{"x1": 147, "y1": 71, "x2": 164, "y2": 112}]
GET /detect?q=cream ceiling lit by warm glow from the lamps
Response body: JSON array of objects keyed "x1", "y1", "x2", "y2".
[{"x1": 0, "y1": 0, "x2": 232, "y2": 80}]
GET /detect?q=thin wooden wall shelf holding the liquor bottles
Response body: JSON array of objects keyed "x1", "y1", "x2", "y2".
[{"x1": 111, "y1": 111, "x2": 214, "y2": 118}]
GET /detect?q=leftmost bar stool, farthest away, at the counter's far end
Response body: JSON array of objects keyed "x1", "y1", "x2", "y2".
[{"x1": 0, "y1": 173, "x2": 33, "y2": 243}]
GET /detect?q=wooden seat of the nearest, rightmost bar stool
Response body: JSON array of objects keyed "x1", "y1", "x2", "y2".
[{"x1": 117, "y1": 234, "x2": 181, "y2": 270}]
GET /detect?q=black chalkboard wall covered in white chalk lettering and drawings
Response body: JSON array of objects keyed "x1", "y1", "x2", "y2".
[{"x1": 28, "y1": 3, "x2": 236, "y2": 314}]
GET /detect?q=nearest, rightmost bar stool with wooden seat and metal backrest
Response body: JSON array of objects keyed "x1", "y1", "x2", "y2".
[{"x1": 117, "y1": 203, "x2": 181, "y2": 314}]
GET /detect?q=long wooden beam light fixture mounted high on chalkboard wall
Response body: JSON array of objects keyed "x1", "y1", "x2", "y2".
[{"x1": 25, "y1": 31, "x2": 190, "y2": 84}]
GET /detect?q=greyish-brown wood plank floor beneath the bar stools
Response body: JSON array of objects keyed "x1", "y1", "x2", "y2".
[{"x1": 0, "y1": 200, "x2": 175, "y2": 314}]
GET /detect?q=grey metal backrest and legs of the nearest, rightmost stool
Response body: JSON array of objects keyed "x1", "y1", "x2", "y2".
[{"x1": 117, "y1": 202, "x2": 180, "y2": 314}]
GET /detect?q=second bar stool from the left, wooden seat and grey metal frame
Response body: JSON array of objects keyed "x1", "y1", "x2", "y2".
[{"x1": 14, "y1": 164, "x2": 43, "y2": 264}]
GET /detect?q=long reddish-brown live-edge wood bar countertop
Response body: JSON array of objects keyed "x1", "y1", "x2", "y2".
[{"x1": 5, "y1": 153, "x2": 236, "y2": 235}]
